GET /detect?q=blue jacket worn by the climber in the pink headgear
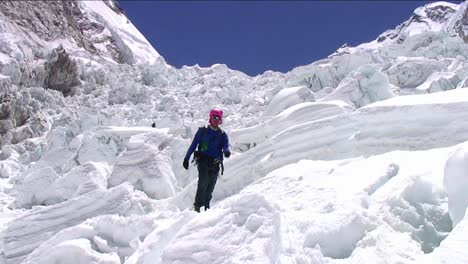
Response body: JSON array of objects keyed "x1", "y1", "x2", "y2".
[{"x1": 185, "y1": 126, "x2": 230, "y2": 160}]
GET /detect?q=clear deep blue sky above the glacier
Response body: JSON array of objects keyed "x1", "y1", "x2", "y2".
[{"x1": 120, "y1": 1, "x2": 436, "y2": 76}]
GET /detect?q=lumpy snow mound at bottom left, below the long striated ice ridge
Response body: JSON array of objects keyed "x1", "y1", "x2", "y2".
[{"x1": 23, "y1": 215, "x2": 159, "y2": 264}]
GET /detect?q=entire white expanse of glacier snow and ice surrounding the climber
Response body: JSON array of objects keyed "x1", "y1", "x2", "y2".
[{"x1": 0, "y1": 1, "x2": 468, "y2": 264}]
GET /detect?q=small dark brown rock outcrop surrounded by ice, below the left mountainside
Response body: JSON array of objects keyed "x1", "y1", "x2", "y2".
[{"x1": 44, "y1": 47, "x2": 80, "y2": 96}]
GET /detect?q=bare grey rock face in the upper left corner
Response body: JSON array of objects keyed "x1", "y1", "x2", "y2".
[{"x1": 0, "y1": 0, "x2": 122, "y2": 62}]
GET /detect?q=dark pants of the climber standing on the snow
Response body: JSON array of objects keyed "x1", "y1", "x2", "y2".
[{"x1": 194, "y1": 158, "x2": 219, "y2": 209}]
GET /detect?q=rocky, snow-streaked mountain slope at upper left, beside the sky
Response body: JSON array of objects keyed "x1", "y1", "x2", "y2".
[{"x1": 0, "y1": 0, "x2": 160, "y2": 64}]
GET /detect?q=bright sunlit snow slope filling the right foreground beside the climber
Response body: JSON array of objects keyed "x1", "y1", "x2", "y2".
[{"x1": 128, "y1": 143, "x2": 462, "y2": 263}]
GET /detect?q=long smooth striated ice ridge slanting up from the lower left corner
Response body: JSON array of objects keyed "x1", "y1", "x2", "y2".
[{"x1": 2, "y1": 185, "x2": 131, "y2": 264}]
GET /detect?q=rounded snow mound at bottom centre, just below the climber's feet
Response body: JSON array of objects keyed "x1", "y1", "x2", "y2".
[{"x1": 161, "y1": 194, "x2": 281, "y2": 263}]
